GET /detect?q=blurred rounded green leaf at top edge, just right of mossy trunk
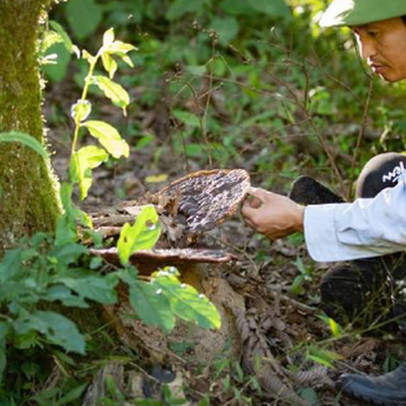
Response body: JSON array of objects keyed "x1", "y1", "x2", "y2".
[{"x1": 66, "y1": 0, "x2": 103, "y2": 40}]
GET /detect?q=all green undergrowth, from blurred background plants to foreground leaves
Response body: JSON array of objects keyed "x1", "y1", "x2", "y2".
[{"x1": 0, "y1": 0, "x2": 406, "y2": 406}]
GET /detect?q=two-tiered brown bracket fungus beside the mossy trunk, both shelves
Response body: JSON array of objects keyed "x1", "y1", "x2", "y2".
[{"x1": 91, "y1": 169, "x2": 250, "y2": 270}]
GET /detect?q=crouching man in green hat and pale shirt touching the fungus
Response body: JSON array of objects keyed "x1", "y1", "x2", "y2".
[{"x1": 242, "y1": 0, "x2": 406, "y2": 406}]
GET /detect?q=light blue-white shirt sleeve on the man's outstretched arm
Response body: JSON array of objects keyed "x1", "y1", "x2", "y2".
[{"x1": 304, "y1": 172, "x2": 406, "y2": 262}]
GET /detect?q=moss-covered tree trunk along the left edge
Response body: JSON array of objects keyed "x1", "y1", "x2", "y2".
[{"x1": 0, "y1": 0, "x2": 60, "y2": 253}]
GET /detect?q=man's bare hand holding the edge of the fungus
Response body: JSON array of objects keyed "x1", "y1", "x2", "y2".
[{"x1": 241, "y1": 188, "x2": 304, "y2": 240}]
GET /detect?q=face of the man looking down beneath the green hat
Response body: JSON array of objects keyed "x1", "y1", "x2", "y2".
[{"x1": 351, "y1": 17, "x2": 406, "y2": 82}]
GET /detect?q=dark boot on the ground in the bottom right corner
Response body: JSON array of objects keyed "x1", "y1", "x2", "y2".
[{"x1": 337, "y1": 363, "x2": 406, "y2": 406}]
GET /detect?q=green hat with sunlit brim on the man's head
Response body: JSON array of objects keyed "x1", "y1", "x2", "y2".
[{"x1": 320, "y1": 0, "x2": 406, "y2": 27}]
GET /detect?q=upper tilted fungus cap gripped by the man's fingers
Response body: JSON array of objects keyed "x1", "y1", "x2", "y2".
[{"x1": 155, "y1": 169, "x2": 250, "y2": 234}]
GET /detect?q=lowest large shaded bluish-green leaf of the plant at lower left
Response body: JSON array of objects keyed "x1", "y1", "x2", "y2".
[{"x1": 13, "y1": 311, "x2": 85, "y2": 354}]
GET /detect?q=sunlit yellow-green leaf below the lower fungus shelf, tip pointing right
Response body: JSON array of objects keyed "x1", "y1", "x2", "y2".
[{"x1": 151, "y1": 270, "x2": 221, "y2": 329}]
